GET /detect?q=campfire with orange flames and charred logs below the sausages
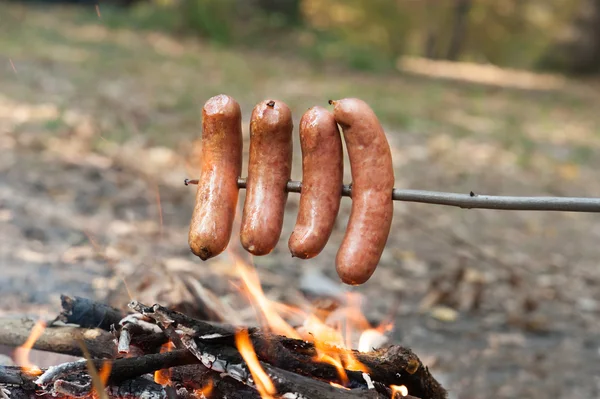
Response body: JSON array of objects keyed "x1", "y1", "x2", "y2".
[{"x1": 0, "y1": 259, "x2": 446, "y2": 399}]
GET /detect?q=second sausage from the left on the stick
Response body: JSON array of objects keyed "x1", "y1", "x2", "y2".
[{"x1": 240, "y1": 100, "x2": 293, "y2": 255}]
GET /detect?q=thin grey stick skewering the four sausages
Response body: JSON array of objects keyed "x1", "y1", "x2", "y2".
[{"x1": 184, "y1": 177, "x2": 600, "y2": 213}]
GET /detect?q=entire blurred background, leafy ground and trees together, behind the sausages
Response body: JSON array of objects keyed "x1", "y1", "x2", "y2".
[{"x1": 0, "y1": 0, "x2": 600, "y2": 399}]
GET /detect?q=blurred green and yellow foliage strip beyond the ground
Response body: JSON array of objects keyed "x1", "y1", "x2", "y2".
[{"x1": 58, "y1": 0, "x2": 600, "y2": 74}]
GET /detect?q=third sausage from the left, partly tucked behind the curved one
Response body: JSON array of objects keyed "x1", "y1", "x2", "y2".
[{"x1": 288, "y1": 106, "x2": 344, "y2": 259}]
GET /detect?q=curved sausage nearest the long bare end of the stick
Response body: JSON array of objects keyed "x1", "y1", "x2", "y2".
[{"x1": 330, "y1": 98, "x2": 394, "y2": 285}]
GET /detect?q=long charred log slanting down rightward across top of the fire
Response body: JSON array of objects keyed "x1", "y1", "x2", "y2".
[{"x1": 130, "y1": 302, "x2": 447, "y2": 398}]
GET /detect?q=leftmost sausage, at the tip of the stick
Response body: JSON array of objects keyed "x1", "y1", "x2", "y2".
[{"x1": 188, "y1": 94, "x2": 243, "y2": 260}]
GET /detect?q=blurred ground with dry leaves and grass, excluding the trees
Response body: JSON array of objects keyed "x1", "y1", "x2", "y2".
[{"x1": 0, "y1": 4, "x2": 600, "y2": 399}]
